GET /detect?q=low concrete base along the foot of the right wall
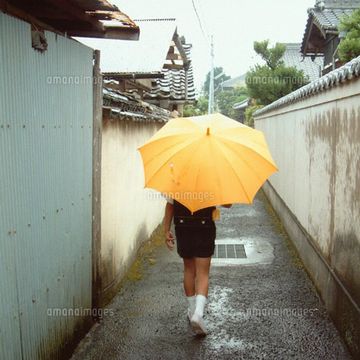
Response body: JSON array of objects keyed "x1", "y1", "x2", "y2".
[{"x1": 263, "y1": 182, "x2": 360, "y2": 359}]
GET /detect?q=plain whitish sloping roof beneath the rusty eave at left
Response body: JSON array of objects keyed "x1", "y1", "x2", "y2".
[{"x1": 77, "y1": 19, "x2": 176, "y2": 73}]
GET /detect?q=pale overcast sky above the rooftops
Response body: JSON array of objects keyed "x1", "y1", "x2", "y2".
[{"x1": 111, "y1": 0, "x2": 316, "y2": 88}]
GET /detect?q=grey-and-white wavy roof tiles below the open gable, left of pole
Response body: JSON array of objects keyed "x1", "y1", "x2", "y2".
[{"x1": 144, "y1": 44, "x2": 195, "y2": 100}]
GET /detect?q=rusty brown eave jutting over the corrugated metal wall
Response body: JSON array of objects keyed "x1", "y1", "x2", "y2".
[{"x1": 0, "y1": 0, "x2": 139, "y2": 40}]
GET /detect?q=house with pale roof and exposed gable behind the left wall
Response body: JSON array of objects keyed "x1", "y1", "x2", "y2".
[{"x1": 79, "y1": 18, "x2": 195, "y2": 114}]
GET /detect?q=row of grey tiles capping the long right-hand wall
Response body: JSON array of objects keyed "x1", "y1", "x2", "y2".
[{"x1": 255, "y1": 56, "x2": 360, "y2": 116}]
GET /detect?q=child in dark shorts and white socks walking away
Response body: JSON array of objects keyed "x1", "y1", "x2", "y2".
[{"x1": 164, "y1": 197, "x2": 231, "y2": 335}]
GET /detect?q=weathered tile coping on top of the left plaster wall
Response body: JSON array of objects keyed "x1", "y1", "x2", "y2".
[{"x1": 103, "y1": 86, "x2": 170, "y2": 122}]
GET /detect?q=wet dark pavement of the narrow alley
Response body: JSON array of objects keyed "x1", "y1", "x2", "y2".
[{"x1": 72, "y1": 192, "x2": 351, "y2": 360}]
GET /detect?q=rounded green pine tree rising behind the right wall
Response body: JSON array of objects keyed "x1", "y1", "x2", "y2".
[{"x1": 246, "y1": 40, "x2": 309, "y2": 105}]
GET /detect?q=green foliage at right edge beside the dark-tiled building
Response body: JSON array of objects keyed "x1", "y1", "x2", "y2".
[{"x1": 339, "y1": 9, "x2": 360, "y2": 62}]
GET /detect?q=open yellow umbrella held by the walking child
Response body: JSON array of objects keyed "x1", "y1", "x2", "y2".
[{"x1": 139, "y1": 114, "x2": 277, "y2": 212}]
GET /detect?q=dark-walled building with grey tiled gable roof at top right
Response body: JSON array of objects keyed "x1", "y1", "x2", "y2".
[{"x1": 301, "y1": 0, "x2": 360, "y2": 74}]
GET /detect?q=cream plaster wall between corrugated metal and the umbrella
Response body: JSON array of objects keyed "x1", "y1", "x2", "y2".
[{"x1": 101, "y1": 119, "x2": 165, "y2": 289}]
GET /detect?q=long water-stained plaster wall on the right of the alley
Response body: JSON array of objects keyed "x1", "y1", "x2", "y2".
[{"x1": 255, "y1": 78, "x2": 360, "y2": 300}]
